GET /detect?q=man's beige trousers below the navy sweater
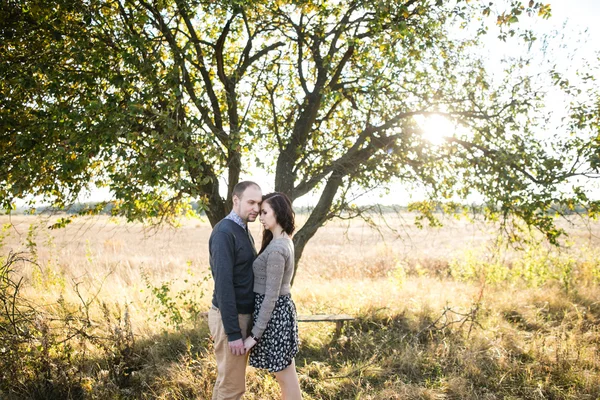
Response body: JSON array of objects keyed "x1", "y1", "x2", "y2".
[{"x1": 208, "y1": 307, "x2": 252, "y2": 400}]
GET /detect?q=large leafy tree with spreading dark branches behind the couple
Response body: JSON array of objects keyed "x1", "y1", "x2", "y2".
[{"x1": 0, "y1": 0, "x2": 598, "y2": 276}]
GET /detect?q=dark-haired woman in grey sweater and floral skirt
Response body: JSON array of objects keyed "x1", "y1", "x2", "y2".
[{"x1": 244, "y1": 192, "x2": 302, "y2": 400}]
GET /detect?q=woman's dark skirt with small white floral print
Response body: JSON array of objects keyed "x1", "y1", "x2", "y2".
[{"x1": 250, "y1": 293, "x2": 298, "y2": 372}]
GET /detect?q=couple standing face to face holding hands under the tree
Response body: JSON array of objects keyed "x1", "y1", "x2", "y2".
[{"x1": 208, "y1": 181, "x2": 302, "y2": 400}]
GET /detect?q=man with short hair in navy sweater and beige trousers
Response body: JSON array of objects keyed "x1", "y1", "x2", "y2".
[{"x1": 208, "y1": 181, "x2": 262, "y2": 400}]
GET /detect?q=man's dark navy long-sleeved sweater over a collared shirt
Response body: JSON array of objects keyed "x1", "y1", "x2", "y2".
[{"x1": 208, "y1": 219, "x2": 256, "y2": 342}]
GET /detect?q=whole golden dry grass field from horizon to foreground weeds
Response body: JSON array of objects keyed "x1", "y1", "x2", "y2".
[{"x1": 0, "y1": 214, "x2": 600, "y2": 399}]
